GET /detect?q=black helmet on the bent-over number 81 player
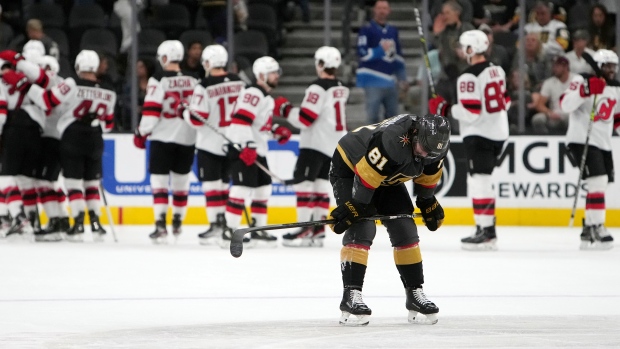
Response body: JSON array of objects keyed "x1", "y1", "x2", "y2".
[{"x1": 412, "y1": 115, "x2": 450, "y2": 159}]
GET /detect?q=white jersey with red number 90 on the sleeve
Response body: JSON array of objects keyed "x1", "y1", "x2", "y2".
[{"x1": 226, "y1": 85, "x2": 275, "y2": 156}]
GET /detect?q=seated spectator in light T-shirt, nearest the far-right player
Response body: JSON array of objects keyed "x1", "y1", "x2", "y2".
[{"x1": 532, "y1": 56, "x2": 575, "y2": 135}]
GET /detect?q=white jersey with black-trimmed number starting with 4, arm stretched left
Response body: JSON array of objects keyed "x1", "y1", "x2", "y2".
[{"x1": 28, "y1": 78, "x2": 116, "y2": 137}]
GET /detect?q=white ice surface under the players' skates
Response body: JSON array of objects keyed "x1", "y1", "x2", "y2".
[{"x1": 0, "y1": 226, "x2": 620, "y2": 349}]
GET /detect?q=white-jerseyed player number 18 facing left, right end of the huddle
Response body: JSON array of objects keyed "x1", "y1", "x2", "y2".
[{"x1": 274, "y1": 46, "x2": 349, "y2": 247}]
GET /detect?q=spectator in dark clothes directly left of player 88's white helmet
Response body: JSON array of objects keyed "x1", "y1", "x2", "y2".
[{"x1": 433, "y1": 0, "x2": 476, "y2": 104}]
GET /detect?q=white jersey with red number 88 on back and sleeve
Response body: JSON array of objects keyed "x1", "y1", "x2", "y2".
[{"x1": 452, "y1": 62, "x2": 510, "y2": 141}]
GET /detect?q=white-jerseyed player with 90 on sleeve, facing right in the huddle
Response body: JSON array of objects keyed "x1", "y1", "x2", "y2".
[{"x1": 221, "y1": 56, "x2": 291, "y2": 248}]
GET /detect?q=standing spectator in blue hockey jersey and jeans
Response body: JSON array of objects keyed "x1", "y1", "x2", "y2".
[{"x1": 356, "y1": 0, "x2": 409, "y2": 124}]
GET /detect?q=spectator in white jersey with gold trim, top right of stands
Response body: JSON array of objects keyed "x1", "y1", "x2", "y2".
[{"x1": 524, "y1": 1, "x2": 570, "y2": 57}]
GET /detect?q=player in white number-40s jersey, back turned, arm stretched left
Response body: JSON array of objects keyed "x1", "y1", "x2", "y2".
[{"x1": 23, "y1": 50, "x2": 116, "y2": 242}]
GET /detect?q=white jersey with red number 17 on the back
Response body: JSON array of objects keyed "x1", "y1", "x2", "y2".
[{"x1": 183, "y1": 73, "x2": 245, "y2": 156}]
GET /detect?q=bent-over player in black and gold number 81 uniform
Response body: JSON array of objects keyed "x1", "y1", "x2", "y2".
[{"x1": 329, "y1": 114, "x2": 450, "y2": 325}]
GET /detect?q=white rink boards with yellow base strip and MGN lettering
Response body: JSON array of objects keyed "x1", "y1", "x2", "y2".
[{"x1": 97, "y1": 134, "x2": 620, "y2": 226}]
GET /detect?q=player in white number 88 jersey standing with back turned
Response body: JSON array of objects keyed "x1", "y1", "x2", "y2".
[{"x1": 429, "y1": 30, "x2": 510, "y2": 250}]
